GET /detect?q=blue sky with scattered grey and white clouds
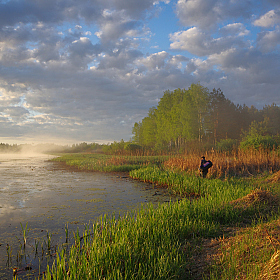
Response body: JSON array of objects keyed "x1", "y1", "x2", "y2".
[{"x1": 0, "y1": 0, "x2": 280, "y2": 144}]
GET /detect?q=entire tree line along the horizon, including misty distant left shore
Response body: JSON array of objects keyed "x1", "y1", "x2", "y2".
[{"x1": 0, "y1": 83, "x2": 280, "y2": 155}]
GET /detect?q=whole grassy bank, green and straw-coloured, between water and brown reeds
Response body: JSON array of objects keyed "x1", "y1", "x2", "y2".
[{"x1": 44, "y1": 155, "x2": 280, "y2": 279}]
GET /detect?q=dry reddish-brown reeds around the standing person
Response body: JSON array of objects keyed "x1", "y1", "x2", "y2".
[{"x1": 164, "y1": 149, "x2": 280, "y2": 178}]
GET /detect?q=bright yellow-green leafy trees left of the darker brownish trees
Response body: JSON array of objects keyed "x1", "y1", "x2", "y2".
[{"x1": 132, "y1": 84, "x2": 208, "y2": 149}]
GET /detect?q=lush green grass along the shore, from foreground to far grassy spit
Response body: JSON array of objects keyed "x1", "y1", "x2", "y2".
[{"x1": 44, "y1": 155, "x2": 278, "y2": 280}]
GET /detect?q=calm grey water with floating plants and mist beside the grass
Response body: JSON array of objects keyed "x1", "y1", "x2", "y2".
[{"x1": 0, "y1": 154, "x2": 174, "y2": 279}]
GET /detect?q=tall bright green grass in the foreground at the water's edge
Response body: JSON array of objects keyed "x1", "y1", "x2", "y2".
[{"x1": 42, "y1": 170, "x2": 270, "y2": 279}]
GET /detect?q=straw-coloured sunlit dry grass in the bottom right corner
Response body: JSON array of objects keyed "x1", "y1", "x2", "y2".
[{"x1": 208, "y1": 218, "x2": 280, "y2": 280}]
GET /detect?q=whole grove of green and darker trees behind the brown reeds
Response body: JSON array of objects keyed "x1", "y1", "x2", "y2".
[{"x1": 132, "y1": 84, "x2": 280, "y2": 150}]
